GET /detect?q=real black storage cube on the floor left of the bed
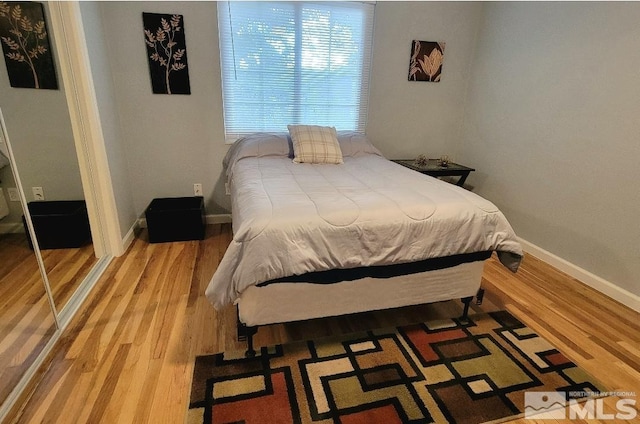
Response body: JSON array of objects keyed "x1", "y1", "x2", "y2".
[{"x1": 145, "y1": 196, "x2": 205, "y2": 243}]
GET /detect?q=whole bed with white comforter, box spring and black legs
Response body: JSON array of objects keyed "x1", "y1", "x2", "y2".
[{"x1": 206, "y1": 132, "x2": 522, "y2": 353}]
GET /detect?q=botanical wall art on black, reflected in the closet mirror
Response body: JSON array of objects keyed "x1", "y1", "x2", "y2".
[{"x1": 0, "y1": 1, "x2": 58, "y2": 90}]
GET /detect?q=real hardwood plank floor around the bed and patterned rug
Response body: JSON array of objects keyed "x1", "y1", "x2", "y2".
[{"x1": 6, "y1": 225, "x2": 640, "y2": 423}]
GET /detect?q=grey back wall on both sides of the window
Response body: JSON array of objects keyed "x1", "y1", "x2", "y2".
[{"x1": 95, "y1": 2, "x2": 481, "y2": 214}]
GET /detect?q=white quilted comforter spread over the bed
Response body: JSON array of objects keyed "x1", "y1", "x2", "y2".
[{"x1": 206, "y1": 135, "x2": 522, "y2": 308}]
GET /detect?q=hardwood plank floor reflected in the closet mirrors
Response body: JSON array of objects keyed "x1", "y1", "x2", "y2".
[{"x1": 0, "y1": 233, "x2": 97, "y2": 408}]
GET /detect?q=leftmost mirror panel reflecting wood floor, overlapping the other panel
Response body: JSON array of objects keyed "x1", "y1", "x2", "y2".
[{"x1": 0, "y1": 126, "x2": 56, "y2": 405}]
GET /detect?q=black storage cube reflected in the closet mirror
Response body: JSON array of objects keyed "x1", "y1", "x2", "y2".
[{"x1": 27, "y1": 200, "x2": 91, "y2": 249}]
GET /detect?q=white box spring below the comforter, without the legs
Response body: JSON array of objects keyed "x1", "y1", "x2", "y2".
[{"x1": 237, "y1": 261, "x2": 484, "y2": 326}]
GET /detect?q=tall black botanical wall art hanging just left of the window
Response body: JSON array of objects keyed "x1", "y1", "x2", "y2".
[{"x1": 142, "y1": 13, "x2": 191, "y2": 94}]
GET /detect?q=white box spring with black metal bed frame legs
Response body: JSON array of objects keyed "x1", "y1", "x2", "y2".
[{"x1": 232, "y1": 252, "x2": 490, "y2": 357}]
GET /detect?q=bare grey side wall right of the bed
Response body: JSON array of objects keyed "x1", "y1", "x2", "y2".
[{"x1": 461, "y1": 2, "x2": 640, "y2": 295}]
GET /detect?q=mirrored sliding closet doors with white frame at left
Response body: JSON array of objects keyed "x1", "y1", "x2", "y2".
[{"x1": 0, "y1": 1, "x2": 111, "y2": 421}]
